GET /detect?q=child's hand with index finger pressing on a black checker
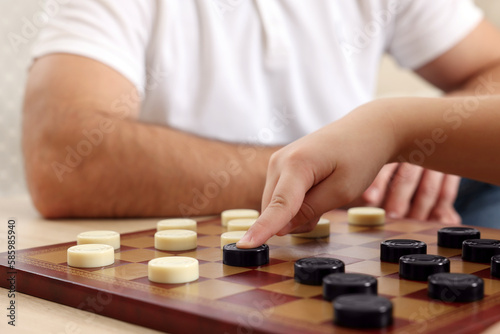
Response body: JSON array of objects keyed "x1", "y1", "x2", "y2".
[{"x1": 238, "y1": 102, "x2": 395, "y2": 248}]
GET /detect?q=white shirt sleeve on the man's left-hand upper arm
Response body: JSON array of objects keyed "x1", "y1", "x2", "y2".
[{"x1": 31, "y1": 0, "x2": 155, "y2": 94}]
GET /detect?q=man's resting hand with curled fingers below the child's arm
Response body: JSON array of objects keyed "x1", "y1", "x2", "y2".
[{"x1": 362, "y1": 163, "x2": 461, "y2": 225}]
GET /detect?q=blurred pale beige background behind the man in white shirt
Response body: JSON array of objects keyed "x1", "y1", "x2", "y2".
[{"x1": 0, "y1": 0, "x2": 500, "y2": 198}]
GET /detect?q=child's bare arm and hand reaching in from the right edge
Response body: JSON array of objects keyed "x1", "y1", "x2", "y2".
[{"x1": 238, "y1": 96, "x2": 500, "y2": 248}]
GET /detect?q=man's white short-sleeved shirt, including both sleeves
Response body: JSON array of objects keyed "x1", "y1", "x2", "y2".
[{"x1": 33, "y1": 0, "x2": 482, "y2": 145}]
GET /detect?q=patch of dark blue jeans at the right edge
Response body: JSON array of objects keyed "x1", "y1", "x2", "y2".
[{"x1": 455, "y1": 178, "x2": 500, "y2": 228}]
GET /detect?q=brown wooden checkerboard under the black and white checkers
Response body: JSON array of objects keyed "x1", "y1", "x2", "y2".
[{"x1": 0, "y1": 211, "x2": 500, "y2": 333}]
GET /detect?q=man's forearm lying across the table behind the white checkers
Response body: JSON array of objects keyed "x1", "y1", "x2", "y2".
[{"x1": 24, "y1": 105, "x2": 274, "y2": 217}]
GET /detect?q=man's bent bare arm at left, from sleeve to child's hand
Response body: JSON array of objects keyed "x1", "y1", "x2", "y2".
[{"x1": 23, "y1": 54, "x2": 275, "y2": 218}]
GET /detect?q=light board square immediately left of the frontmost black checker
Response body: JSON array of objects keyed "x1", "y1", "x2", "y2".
[{"x1": 269, "y1": 299, "x2": 333, "y2": 324}]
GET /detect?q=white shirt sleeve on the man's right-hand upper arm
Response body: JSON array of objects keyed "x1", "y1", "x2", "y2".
[{"x1": 387, "y1": 0, "x2": 483, "y2": 69}]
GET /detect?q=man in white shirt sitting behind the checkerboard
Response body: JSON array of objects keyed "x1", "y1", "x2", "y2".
[{"x1": 23, "y1": 0, "x2": 500, "y2": 227}]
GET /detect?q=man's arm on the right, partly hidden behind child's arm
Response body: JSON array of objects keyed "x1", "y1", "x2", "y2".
[{"x1": 363, "y1": 21, "x2": 500, "y2": 223}]
